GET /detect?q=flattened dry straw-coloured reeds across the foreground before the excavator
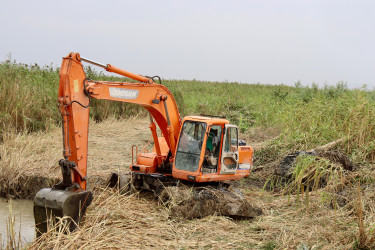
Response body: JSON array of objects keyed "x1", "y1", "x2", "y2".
[{"x1": 25, "y1": 183, "x2": 371, "y2": 249}]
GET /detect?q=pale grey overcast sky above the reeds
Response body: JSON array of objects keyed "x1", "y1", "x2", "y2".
[{"x1": 0, "y1": 0, "x2": 375, "y2": 89}]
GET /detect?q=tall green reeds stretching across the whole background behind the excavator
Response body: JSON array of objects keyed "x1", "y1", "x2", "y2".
[{"x1": 0, "y1": 61, "x2": 375, "y2": 162}]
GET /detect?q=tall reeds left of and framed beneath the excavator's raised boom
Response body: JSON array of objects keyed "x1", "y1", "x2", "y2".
[{"x1": 0, "y1": 61, "x2": 142, "y2": 134}]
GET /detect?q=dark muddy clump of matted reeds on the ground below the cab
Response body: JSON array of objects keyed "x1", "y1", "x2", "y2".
[{"x1": 161, "y1": 187, "x2": 262, "y2": 219}]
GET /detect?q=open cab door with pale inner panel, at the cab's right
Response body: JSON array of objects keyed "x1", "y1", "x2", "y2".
[{"x1": 220, "y1": 124, "x2": 239, "y2": 174}]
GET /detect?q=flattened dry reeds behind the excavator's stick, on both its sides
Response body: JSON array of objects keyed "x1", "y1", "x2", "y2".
[{"x1": 0, "y1": 118, "x2": 150, "y2": 198}]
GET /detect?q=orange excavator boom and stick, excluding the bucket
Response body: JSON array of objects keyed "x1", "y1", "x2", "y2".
[{"x1": 58, "y1": 53, "x2": 181, "y2": 189}]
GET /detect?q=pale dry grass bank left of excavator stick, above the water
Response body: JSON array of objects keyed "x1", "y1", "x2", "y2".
[{"x1": 0, "y1": 129, "x2": 59, "y2": 198}]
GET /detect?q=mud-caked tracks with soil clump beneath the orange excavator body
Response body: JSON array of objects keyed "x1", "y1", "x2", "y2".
[{"x1": 109, "y1": 172, "x2": 262, "y2": 219}]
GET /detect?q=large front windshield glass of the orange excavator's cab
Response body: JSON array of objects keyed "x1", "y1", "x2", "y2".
[{"x1": 175, "y1": 121, "x2": 207, "y2": 172}]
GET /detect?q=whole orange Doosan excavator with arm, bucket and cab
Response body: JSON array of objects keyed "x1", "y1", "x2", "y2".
[{"x1": 34, "y1": 53, "x2": 253, "y2": 232}]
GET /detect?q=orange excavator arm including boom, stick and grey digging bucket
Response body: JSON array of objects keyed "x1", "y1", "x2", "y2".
[{"x1": 34, "y1": 53, "x2": 181, "y2": 232}]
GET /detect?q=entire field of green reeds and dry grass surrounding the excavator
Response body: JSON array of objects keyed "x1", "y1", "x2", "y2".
[{"x1": 0, "y1": 62, "x2": 375, "y2": 249}]
